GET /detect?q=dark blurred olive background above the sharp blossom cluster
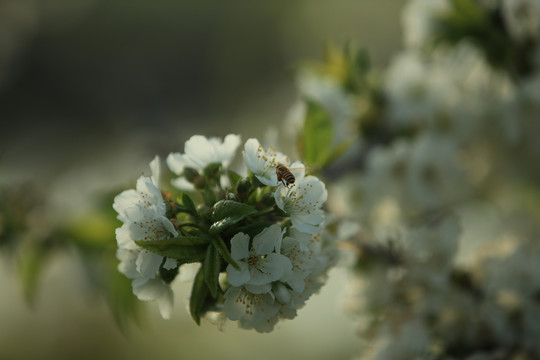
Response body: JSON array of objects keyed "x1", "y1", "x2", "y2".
[{"x1": 0, "y1": 0, "x2": 403, "y2": 183}]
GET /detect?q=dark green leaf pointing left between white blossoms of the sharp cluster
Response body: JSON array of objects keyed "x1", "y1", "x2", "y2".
[{"x1": 135, "y1": 236, "x2": 210, "y2": 263}]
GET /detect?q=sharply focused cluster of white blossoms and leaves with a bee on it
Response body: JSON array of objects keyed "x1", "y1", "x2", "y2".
[{"x1": 113, "y1": 135, "x2": 335, "y2": 332}]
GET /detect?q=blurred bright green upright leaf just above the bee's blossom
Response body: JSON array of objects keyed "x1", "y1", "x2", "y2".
[{"x1": 301, "y1": 100, "x2": 334, "y2": 167}]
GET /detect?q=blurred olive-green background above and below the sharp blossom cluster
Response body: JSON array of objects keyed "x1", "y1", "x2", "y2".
[{"x1": 0, "y1": 0, "x2": 404, "y2": 359}]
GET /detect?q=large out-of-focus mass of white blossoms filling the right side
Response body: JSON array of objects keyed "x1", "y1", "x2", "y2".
[{"x1": 308, "y1": 0, "x2": 540, "y2": 360}]
